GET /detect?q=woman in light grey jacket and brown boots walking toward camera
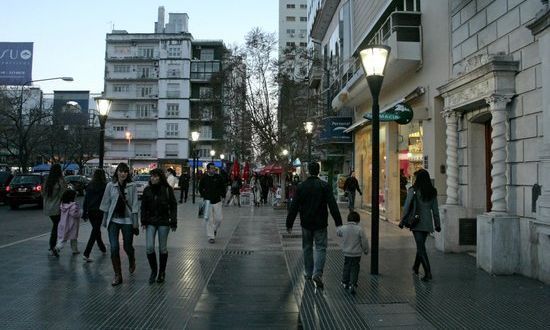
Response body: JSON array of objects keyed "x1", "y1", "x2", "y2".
[{"x1": 99, "y1": 163, "x2": 139, "y2": 286}]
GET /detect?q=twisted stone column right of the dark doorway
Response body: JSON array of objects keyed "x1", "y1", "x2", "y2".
[{"x1": 485, "y1": 95, "x2": 511, "y2": 213}]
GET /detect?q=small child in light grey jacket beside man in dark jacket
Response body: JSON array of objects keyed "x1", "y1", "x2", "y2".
[{"x1": 338, "y1": 211, "x2": 369, "y2": 294}]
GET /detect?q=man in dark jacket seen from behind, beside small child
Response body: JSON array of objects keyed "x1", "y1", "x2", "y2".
[{"x1": 286, "y1": 162, "x2": 342, "y2": 288}]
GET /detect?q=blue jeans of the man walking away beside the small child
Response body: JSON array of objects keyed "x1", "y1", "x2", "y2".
[{"x1": 302, "y1": 227, "x2": 328, "y2": 277}]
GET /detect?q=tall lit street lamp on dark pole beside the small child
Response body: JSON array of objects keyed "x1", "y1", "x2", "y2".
[{"x1": 359, "y1": 45, "x2": 390, "y2": 275}]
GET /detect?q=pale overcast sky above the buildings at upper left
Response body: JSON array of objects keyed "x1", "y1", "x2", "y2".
[{"x1": 0, "y1": 0, "x2": 278, "y2": 93}]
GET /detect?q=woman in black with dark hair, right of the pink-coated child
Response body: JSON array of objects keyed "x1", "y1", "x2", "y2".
[{"x1": 82, "y1": 169, "x2": 107, "y2": 262}]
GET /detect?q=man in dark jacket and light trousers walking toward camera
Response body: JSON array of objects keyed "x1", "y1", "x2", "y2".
[{"x1": 199, "y1": 163, "x2": 226, "y2": 244}]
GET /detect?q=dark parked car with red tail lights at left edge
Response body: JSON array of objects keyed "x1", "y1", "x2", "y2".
[{"x1": 6, "y1": 174, "x2": 46, "y2": 209}]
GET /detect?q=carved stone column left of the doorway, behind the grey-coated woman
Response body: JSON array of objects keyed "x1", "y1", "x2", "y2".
[{"x1": 443, "y1": 109, "x2": 458, "y2": 205}]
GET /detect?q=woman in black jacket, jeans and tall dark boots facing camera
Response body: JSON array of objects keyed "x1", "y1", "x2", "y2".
[{"x1": 141, "y1": 169, "x2": 177, "y2": 284}]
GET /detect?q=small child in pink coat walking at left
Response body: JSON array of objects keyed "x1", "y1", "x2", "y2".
[{"x1": 55, "y1": 189, "x2": 80, "y2": 254}]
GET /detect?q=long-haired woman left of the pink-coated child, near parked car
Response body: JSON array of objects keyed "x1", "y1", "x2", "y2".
[{"x1": 42, "y1": 164, "x2": 67, "y2": 257}]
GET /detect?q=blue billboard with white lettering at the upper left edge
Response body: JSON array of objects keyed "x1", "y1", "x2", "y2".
[{"x1": 0, "y1": 42, "x2": 33, "y2": 85}]
